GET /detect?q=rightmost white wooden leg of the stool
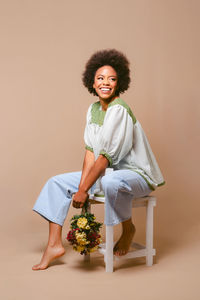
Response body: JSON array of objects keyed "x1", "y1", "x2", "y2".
[{"x1": 146, "y1": 201, "x2": 154, "y2": 266}]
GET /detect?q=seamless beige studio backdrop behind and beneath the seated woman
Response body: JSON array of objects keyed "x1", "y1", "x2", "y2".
[{"x1": 0, "y1": 0, "x2": 200, "y2": 300}]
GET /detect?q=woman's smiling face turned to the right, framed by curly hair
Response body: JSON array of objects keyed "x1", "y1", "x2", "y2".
[{"x1": 93, "y1": 66, "x2": 117, "y2": 102}]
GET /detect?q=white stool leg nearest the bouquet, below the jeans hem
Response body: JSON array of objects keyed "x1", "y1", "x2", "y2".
[{"x1": 105, "y1": 226, "x2": 113, "y2": 273}]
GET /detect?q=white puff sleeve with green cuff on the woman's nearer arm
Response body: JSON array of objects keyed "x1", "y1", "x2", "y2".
[{"x1": 98, "y1": 105, "x2": 133, "y2": 166}]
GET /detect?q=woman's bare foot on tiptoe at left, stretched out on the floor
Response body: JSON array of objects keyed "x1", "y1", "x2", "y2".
[{"x1": 32, "y1": 245, "x2": 65, "y2": 270}]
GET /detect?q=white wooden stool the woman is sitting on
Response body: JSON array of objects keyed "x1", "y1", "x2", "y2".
[{"x1": 82, "y1": 194, "x2": 156, "y2": 272}]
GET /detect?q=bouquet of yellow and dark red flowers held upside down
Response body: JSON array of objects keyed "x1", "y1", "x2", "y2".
[{"x1": 66, "y1": 201, "x2": 103, "y2": 255}]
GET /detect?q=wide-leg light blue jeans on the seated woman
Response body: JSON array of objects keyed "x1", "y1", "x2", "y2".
[{"x1": 33, "y1": 170, "x2": 152, "y2": 226}]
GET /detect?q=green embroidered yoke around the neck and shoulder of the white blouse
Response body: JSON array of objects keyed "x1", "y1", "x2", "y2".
[{"x1": 91, "y1": 98, "x2": 136, "y2": 126}]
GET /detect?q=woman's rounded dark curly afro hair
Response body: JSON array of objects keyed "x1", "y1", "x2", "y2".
[{"x1": 82, "y1": 49, "x2": 131, "y2": 96}]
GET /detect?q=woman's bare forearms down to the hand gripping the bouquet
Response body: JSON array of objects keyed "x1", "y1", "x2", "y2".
[{"x1": 73, "y1": 153, "x2": 108, "y2": 208}]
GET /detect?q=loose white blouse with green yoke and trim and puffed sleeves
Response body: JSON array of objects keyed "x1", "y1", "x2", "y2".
[{"x1": 84, "y1": 98, "x2": 164, "y2": 190}]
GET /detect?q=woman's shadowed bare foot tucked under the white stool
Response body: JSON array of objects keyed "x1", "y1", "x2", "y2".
[{"x1": 113, "y1": 223, "x2": 136, "y2": 256}]
